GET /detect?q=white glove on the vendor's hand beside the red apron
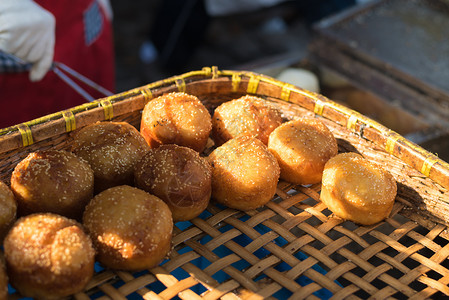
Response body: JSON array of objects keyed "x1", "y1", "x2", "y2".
[{"x1": 0, "y1": 0, "x2": 55, "y2": 81}]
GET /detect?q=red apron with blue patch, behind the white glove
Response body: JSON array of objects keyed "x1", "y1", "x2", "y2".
[{"x1": 0, "y1": 0, "x2": 115, "y2": 128}]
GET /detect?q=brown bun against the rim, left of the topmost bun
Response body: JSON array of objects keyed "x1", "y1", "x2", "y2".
[{"x1": 72, "y1": 122, "x2": 150, "y2": 194}]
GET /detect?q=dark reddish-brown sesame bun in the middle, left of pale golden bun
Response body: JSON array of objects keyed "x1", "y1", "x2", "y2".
[{"x1": 134, "y1": 145, "x2": 212, "y2": 221}]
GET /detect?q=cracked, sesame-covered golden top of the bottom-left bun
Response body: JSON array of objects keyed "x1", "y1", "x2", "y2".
[{"x1": 4, "y1": 213, "x2": 95, "y2": 274}]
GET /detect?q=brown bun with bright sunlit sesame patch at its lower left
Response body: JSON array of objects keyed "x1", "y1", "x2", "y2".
[{"x1": 83, "y1": 185, "x2": 173, "y2": 271}]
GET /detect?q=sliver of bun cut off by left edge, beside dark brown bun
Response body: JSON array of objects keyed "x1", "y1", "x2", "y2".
[{"x1": 0, "y1": 181, "x2": 17, "y2": 241}]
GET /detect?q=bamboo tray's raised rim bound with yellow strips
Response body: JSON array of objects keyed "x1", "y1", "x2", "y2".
[{"x1": 0, "y1": 66, "x2": 449, "y2": 189}]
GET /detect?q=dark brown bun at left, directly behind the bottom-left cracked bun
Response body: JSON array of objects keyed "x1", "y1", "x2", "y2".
[{"x1": 11, "y1": 150, "x2": 94, "y2": 219}]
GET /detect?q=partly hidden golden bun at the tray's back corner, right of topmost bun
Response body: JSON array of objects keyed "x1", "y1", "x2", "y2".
[{"x1": 212, "y1": 95, "x2": 282, "y2": 146}]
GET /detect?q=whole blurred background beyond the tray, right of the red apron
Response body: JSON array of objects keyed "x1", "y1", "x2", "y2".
[{"x1": 111, "y1": 0, "x2": 449, "y2": 161}]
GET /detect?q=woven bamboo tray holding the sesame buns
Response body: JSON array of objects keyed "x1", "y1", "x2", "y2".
[{"x1": 0, "y1": 67, "x2": 449, "y2": 299}]
